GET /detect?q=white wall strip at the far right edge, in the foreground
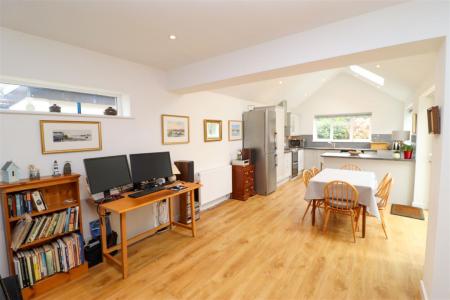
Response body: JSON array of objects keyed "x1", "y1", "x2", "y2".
[{"x1": 422, "y1": 38, "x2": 450, "y2": 299}]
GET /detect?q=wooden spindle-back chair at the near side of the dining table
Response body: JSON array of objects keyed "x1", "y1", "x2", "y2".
[{"x1": 323, "y1": 180, "x2": 361, "y2": 243}]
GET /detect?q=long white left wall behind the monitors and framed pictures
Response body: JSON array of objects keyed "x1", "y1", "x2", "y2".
[{"x1": 0, "y1": 29, "x2": 255, "y2": 275}]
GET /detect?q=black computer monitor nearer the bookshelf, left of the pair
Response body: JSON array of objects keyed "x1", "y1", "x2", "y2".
[{"x1": 84, "y1": 155, "x2": 132, "y2": 194}]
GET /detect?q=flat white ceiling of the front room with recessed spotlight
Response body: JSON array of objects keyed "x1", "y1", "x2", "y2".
[{"x1": 0, "y1": 0, "x2": 405, "y2": 69}]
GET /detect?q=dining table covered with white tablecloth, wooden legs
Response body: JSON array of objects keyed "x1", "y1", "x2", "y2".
[{"x1": 305, "y1": 168, "x2": 380, "y2": 237}]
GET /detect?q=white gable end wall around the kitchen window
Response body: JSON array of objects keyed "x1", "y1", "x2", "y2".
[{"x1": 293, "y1": 73, "x2": 404, "y2": 134}]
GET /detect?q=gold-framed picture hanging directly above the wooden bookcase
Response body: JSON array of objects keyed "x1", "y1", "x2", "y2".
[{"x1": 39, "y1": 120, "x2": 102, "y2": 154}]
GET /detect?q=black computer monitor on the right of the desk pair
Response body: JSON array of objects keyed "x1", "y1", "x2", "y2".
[{"x1": 130, "y1": 152, "x2": 173, "y2": 183}]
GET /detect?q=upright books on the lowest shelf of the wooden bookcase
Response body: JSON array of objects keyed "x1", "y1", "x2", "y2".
[{"x1": 13, "y1": 233, "x2": 84, "y2": 288}]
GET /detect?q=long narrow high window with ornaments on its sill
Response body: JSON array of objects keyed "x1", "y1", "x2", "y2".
[{"x1": 0, "y1": 82, "x2": 120, "y2": 115}]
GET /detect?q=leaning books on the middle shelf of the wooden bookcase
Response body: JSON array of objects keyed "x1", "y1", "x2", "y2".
[{"x1": 11, "y1": 206, "x2": 80, "y2": 251}]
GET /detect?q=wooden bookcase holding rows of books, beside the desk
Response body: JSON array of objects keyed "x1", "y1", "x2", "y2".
[{"x1": 0, "y1": 174, "x2": 87, "y2": 299}]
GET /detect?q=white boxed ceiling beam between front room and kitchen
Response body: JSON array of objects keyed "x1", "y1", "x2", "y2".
[{"x1": 168, "y1": 1, "x2": 450, "y2": 93}]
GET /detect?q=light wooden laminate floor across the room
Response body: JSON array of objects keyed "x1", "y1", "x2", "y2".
[{"x1": 37, "y1": 180, "x2": 427, "y2": 300}]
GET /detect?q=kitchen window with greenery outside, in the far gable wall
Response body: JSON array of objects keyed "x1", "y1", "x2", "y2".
[{"x1": 314, "y1": 114, "x2": 372, "y2": 142}]
